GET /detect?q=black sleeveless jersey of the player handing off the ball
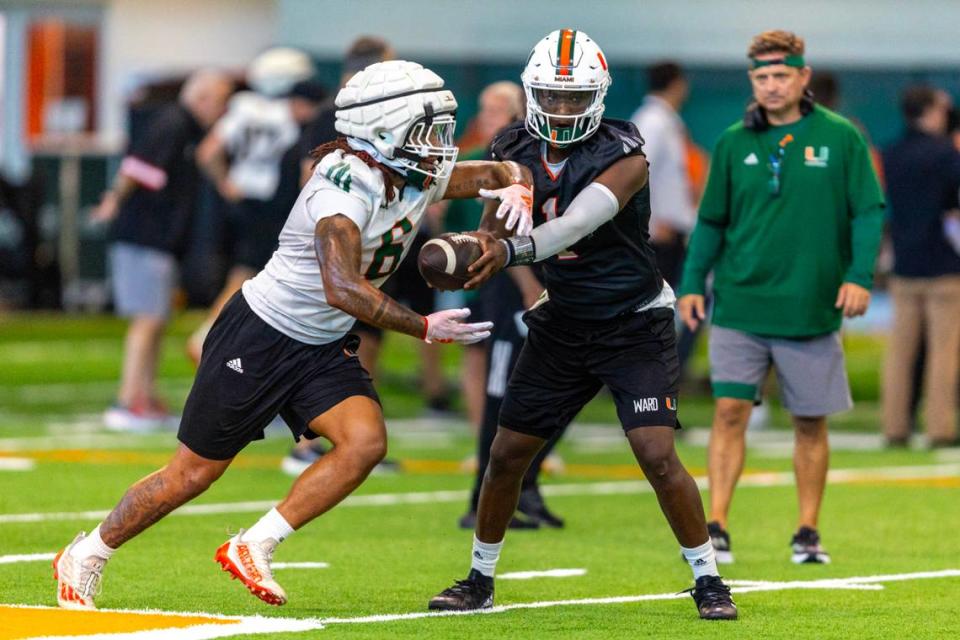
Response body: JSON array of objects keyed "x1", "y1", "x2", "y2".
[{"x1": 492, "y1": 118, "x2": 663, "y2": 321}]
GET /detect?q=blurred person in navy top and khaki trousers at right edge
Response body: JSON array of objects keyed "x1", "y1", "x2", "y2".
[{"x1": 883, "y1": 85, "x2": 960, "y2": 447}]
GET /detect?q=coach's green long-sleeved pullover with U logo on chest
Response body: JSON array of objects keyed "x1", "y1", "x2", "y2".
[{"x1": 680, "y1": 105, "x2": 884, "y2": 338}]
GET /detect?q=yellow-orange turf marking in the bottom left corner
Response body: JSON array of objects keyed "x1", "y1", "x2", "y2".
[{"x1": 0, "y1": 605, "x2": 238, "y2": 640}]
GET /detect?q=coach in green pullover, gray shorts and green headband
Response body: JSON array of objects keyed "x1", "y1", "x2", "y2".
[{"x1": 678, "y1": 31, "x2": 884, "y2": 563}]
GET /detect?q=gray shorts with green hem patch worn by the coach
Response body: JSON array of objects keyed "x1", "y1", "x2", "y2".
[{"x1": 710, "y1": 325, "x2": 853, "y2": 418}]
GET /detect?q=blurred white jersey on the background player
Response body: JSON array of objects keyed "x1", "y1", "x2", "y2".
[{"x1": 217, "y1": 91, "x2": 300, "y2": 200}]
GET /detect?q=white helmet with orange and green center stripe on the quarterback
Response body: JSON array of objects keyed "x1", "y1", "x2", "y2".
[{"x1": 520, "y1": 29, "x2": 612, "y2": 147}]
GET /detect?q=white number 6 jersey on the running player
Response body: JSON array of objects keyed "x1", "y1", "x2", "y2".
[{"x1": 243, "y1": 151, "x2": 449, "y2": 344}]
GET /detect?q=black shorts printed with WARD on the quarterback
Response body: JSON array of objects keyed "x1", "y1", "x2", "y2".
[{"x1": 500, "y1": 302, "x2": 680, "y2": 439}]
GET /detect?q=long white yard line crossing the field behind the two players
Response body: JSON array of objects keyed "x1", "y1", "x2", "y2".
[{"x1": 0, "y1": 463, "x2": 960, "y2": 524}]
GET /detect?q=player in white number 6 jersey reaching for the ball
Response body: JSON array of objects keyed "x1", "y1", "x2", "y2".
[{"x1": 54, "y1": 61, "x2": 532, "y2": 609}]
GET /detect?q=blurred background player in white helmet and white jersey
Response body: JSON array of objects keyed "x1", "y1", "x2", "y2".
[{"x1": 187, "y1": 47, "x2": 325, "y2": 364}]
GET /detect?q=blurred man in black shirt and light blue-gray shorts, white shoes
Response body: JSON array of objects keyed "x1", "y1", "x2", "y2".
[{"x1": 93, "y1": 71, "x2": 233, "y2": 430}]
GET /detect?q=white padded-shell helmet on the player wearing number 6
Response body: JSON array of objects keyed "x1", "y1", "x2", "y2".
[{"x1": 336, "y1": 60, "x2": 457, "y2": 178}]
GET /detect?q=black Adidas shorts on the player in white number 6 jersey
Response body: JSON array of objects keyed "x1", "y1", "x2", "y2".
[{"x1": 177, "y1": 291, "x2": 380, "y2": 460}]
